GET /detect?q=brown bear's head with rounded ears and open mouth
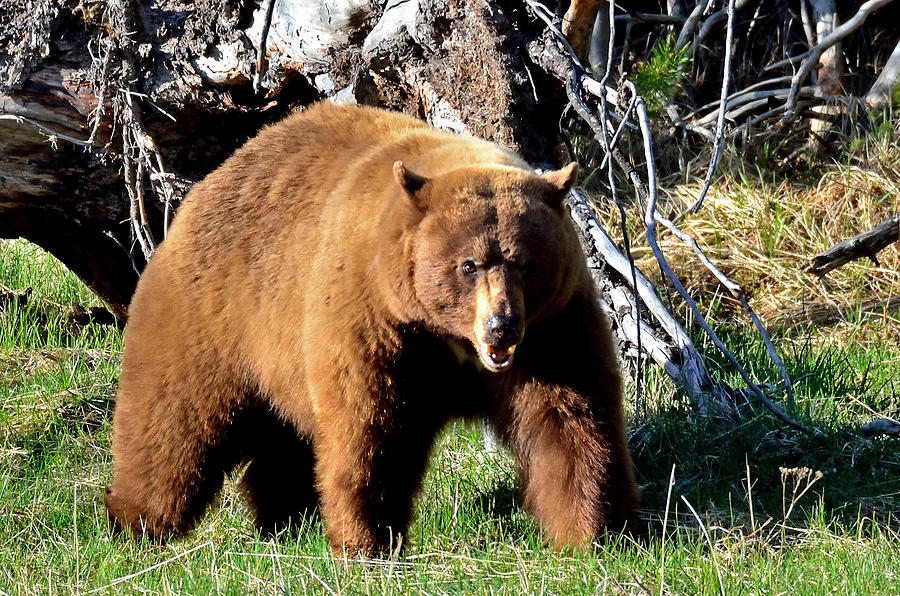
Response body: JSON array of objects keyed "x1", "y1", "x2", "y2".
[{"x1": 394, "y1": 162, "x2": 584, "y2": 372}]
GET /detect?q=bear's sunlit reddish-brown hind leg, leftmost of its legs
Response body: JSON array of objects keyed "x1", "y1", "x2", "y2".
[{"x1": 106, "y1": 354, "x2": 250, "y2": 539}]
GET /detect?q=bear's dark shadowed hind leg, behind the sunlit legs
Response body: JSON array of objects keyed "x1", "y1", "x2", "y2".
[{"x1": 241, "y1": 412, "x2": 318, "y2": 534}]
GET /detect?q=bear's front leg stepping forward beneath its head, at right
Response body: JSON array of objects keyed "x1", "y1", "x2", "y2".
[{"x1": 497, "y1": 302, "x2": 639, "y2": 547}]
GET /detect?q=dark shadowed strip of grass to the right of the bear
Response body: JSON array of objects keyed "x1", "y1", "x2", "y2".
[{"x1": 631, "y1": 411, "x2": 900, "y2": 534}]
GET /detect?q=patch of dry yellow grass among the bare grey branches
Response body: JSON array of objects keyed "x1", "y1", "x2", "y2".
[{"x1": 597, "y1": 126, "x2": 900, "y2": 341}]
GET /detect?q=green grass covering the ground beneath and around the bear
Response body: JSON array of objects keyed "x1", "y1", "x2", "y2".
[{"x1": 0, "y1": 235, "x2": 900, "y2": 594}]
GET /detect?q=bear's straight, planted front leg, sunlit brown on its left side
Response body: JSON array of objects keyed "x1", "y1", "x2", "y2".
[{"x1": 306, "y1": 352, "x2": 436, "y2": 557}]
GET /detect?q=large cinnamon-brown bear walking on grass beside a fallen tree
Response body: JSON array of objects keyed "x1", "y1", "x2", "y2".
[{"x1": 106, "y1": 102, "x2": 637, "y2": 557}]
